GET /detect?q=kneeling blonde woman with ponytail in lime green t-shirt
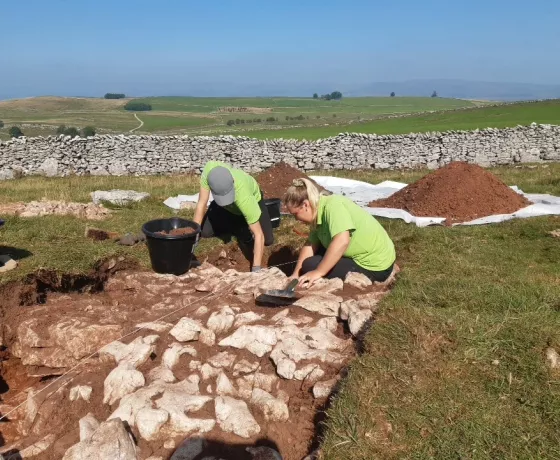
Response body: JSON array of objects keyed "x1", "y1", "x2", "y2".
[{"x1": 283, "y1": 178, "x2": 396, "y2": 286}]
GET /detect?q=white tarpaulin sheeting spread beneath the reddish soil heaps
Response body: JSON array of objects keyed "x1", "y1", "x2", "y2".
[{"x1": 163, "y1": 176, "x2": 560, "y2": 227}]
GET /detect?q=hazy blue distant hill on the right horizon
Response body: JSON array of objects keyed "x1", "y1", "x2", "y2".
[{"x1": 352, "y1": 79, "x2": 560, "y2": 101}]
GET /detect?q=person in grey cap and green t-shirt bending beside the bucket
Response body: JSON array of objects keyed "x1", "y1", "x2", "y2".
[{"x1": 193, "y1": 161, "x2": 274, "y2": 271}]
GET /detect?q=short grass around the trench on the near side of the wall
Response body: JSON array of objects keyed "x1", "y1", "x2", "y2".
[{"x1": 0, "y1": 164, "x2": 560, "y2": 460}]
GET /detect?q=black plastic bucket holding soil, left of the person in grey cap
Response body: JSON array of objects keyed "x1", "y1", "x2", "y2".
[{"x1": 142, "y1": 217, "x2": 200, "y2": 275}]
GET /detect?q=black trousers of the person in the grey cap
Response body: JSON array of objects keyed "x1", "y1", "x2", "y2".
[{"x1": 200, "y1": 200, "x2": 274, "y2": 246}]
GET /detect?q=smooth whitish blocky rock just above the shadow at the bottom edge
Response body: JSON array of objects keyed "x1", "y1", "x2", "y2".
[{"x1": 214, "y1": 396, "x2": 261, "y2": 438}]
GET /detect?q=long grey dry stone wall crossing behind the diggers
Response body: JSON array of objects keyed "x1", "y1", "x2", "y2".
[{"x1": 0, "y1": 123, "x2": 560, "y2": 179}]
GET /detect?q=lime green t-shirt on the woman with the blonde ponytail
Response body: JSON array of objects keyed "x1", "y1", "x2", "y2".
[{"x1": 309, "y1": 195, "x2": 396, "y2": 271}]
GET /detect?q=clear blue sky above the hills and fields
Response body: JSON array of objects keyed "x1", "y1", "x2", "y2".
[{"x1": 0, "y1": 0, "x2": 560, "y2": 98}]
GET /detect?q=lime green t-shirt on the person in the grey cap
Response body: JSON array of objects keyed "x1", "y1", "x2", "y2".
[{"x1": 200, "y1": 161, "x2": 261, "y2": 225}]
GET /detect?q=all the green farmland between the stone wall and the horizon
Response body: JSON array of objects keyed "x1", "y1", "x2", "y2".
[{"x1": 0, "y1": 97, "x2": 560, "y2": 140}]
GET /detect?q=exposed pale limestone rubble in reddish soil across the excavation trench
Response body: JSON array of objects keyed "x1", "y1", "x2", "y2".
[{"x1": 1, "y1": 263, "x2": 394, "y2": 460}]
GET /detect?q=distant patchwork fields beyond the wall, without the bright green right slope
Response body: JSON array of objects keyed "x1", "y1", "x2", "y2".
[{"x1": 0, "y1": 97, "x2": 482, "y2": 139}]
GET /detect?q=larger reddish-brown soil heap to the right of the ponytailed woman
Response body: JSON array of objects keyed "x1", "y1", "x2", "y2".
[{"x1": 369, "y1": 161, "x2": 531, "y2": 225}]
